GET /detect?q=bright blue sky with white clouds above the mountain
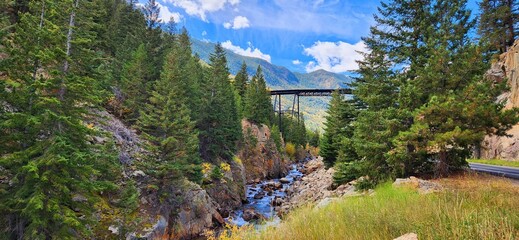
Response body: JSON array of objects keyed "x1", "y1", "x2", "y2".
[{"x1": 140, "y1": 0, "x2": 477, "y2": 73}]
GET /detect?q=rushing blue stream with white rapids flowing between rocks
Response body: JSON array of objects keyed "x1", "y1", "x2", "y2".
[{"x1": 226, "y1": 164, "x2": 303, "y2": 226}]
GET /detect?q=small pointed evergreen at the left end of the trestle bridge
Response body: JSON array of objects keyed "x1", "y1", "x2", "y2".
[{"x1": 243, "y1": 66, "x2": 274, "y2": 125}]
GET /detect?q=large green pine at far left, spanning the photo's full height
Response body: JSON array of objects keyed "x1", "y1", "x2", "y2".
[{"x1": 0, "y1": 0, "x2": 120, "y2": 239}]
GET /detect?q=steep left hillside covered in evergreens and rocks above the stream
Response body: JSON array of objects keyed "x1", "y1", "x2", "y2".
[{"x1": 0, "y1": 0, "x2": 307, "y2": 239}]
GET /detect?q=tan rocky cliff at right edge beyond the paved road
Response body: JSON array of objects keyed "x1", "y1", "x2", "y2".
[{"x1": 481, "y1": 40, "x2": 519, "y2": 160}]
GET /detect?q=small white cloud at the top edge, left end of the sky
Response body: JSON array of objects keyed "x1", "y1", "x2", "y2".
[{"x1": 165, "y1": 0, "x2": 240, "y2": 22}]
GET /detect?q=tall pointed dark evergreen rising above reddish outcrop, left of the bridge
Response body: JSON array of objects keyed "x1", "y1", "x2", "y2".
[{"x1": 199, "y1": 44, "x2": 241, "y2": 162}]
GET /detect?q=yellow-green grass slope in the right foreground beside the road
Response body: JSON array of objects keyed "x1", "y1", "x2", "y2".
[{"x1": 219, "y1": 175, "x2": 519, "y2": 240}]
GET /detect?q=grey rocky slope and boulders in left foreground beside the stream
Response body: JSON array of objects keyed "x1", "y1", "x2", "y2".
[{"x1": 91, "y1": 110, "x2": 225, "y2": 239}]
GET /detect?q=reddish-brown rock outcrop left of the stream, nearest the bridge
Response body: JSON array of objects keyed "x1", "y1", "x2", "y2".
[{"x1": 238, "y1": 120, "x2": 290, "y2": 183}]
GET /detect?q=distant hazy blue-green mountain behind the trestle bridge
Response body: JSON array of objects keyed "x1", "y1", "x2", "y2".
[{"x1": 192, "y1": 39, "x2": 351, "y2": 130}]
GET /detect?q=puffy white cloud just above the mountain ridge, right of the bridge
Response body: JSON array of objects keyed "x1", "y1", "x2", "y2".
[{"x1": 303, "y1": 41, "x2": 367, "y2": 73}]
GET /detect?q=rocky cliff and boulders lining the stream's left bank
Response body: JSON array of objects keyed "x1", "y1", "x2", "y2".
[{"x1": 92, "y1": 113, "x2": 288, "y2": 239}]
